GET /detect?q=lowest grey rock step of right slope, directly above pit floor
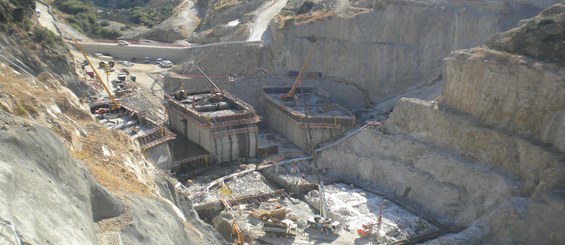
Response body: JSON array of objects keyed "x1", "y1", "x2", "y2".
[{"x1": 319, "y1": 128, "x2": 517, "y2": 226}]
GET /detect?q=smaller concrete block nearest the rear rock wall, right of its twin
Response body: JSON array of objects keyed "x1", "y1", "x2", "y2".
[{"x1": 263, "y1": 87, "x2": 355, "y2": 150}]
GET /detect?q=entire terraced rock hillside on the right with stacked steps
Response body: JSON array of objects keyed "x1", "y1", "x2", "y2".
[{"x1": 320, "y1": 4, "x2": 565, "y2": 244}]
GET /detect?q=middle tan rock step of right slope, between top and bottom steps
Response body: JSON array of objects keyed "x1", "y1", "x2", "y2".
[{"x1": 386, "y1": 99, "x2": 563, "y2": 195}]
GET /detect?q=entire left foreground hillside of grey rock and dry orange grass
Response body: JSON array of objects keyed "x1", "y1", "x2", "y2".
[{"x1": 0, "y1": 4, "x2": 225, "y2": 244}]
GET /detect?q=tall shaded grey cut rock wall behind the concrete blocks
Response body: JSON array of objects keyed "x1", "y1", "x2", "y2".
[{"x1": 270, "y1": 1, "x2": 555, "y2": 104}]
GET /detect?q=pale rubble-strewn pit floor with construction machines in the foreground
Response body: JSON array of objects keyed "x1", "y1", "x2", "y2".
[{"x1": 187, "y1": 159, "x2": 447, "y2": 244}]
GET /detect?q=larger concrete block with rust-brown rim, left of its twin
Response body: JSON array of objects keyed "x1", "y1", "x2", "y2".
[{"x1": 165, "y1": 91, "x2": 260, "y2": 163}]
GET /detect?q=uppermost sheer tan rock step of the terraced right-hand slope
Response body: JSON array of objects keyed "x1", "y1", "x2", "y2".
[{"x1": 440, "y1": 48, "x2": 565, "y2": 144}]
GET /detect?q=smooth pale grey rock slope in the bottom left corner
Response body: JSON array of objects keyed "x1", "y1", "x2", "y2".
[{"x1": 0, "y1": 115, "x2": 111, "y2": 244}]
